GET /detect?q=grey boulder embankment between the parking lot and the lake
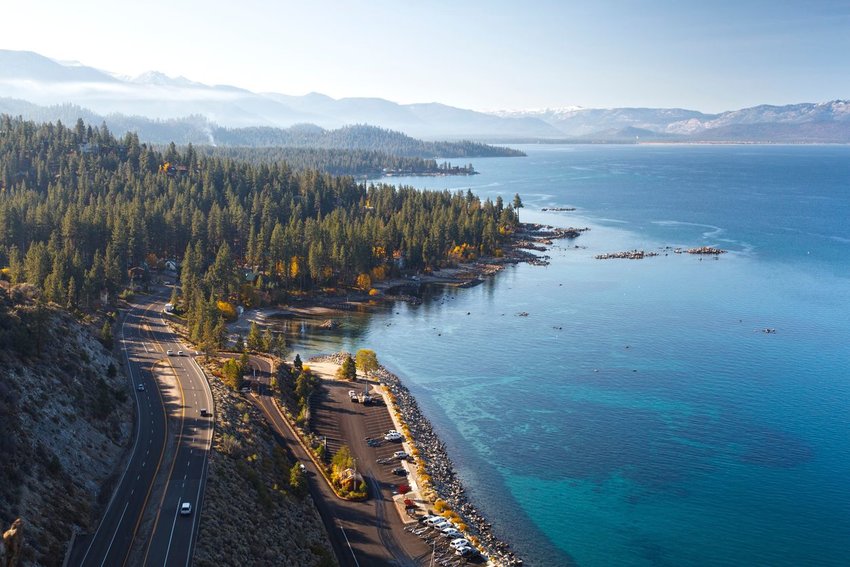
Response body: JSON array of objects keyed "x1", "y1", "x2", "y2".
[{"x1": 310, "y1": 353, "x2": 523, "y2": 567}]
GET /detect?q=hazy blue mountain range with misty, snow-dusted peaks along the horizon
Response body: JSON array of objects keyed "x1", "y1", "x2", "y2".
[{"x1": 0, "y1": 50, "x2": 850, "y2": 143}]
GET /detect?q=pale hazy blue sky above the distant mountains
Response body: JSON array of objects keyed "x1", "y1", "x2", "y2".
[{"x1": 0, "y1": 0, "x2": 850, "y2": 112}]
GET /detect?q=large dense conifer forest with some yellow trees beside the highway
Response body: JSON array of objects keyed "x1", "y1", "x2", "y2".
[{"x1": 0, "y1": 116, "x2": 518, "y2": 324}]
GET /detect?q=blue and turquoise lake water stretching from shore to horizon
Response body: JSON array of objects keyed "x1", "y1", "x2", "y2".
[{"x1": 292, "y1": 146, "x2": 850, "y2": 565}]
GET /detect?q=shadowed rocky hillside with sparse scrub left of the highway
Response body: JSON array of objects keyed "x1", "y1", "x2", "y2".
[{"x1": 0, "y1": 282, "x2": 135, "y2": 565}]
